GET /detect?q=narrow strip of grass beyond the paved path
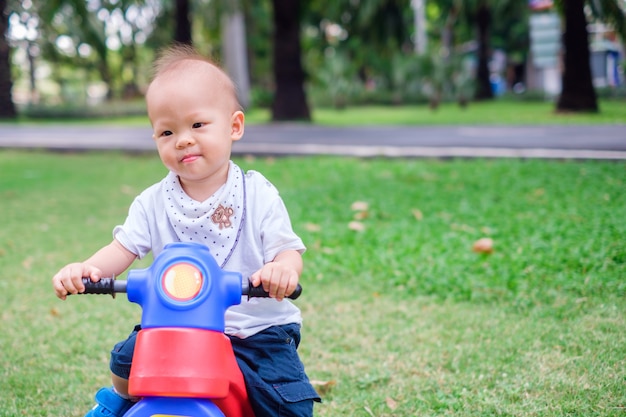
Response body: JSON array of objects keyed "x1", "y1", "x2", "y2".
[{"x1": 5, "y1": 99, "x2": 626, "y2": 126}]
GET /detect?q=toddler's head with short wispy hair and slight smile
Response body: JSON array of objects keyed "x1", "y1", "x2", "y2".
[{"x1": 146, "y1": 62, "x2": 244, "y2": 195}]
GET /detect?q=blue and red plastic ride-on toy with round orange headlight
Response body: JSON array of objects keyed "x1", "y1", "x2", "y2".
[{"x1": 75, "y1": 243, "x2": 302, "y2": 417}]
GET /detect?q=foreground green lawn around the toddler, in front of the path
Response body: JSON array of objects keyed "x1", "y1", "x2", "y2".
[{"x1": 0, "y1": 150, "x2": 626, "y2": 417}]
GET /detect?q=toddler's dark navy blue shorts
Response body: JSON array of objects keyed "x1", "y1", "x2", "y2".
[{"x1": 110, "y1": 324, "x2": 320, "y2": 417}]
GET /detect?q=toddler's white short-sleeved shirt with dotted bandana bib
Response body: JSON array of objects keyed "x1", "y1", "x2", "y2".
[{"x1": 113, "y1": 162, "x2": 305, "y2": 338}]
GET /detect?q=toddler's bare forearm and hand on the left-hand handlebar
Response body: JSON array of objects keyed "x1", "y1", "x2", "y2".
[{"x1": 52, "y1": 240, "x2": 137, "y2": 300}]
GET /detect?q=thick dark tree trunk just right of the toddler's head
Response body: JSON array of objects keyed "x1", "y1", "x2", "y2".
[{"x1": 272, "y1": 0, "x2": 311, "y2": 121}]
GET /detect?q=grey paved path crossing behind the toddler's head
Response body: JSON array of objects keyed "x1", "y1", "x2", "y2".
[{"x1": 0, "y1": 123, "x2": 626, "y2": 159}]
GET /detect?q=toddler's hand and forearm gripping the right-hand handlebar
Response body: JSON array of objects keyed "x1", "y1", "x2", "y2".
[{"x1": 250, "y1": 250, "x2": 302, "y2": 301}]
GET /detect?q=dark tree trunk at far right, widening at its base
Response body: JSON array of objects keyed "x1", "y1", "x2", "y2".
[{"x1": 556, "y1": 0, "x2": 598, "y2": 113}]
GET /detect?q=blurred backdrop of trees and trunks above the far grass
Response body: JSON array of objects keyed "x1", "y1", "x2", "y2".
[{"x1": 0, "y1": 0, "x2": 626, "y2": 121}]
